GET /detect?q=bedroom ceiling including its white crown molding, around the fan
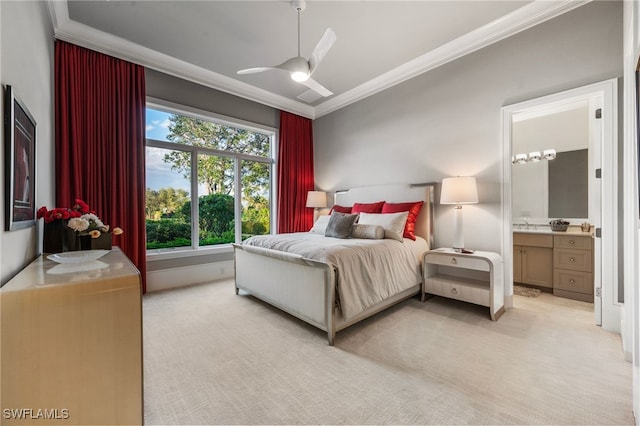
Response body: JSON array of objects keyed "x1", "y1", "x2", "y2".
[{"x1": 49, "y1": 0, "x2": 587, "y2": 118}]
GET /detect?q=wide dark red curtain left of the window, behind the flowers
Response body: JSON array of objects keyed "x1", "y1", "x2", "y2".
[{"x1": 55, "y1": 41, "x2": 146, "y2": 291}]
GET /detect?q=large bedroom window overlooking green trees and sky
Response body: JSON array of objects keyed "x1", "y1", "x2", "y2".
[{"x1": 145, "y1": 105, "x2": 275, "y2": 250}]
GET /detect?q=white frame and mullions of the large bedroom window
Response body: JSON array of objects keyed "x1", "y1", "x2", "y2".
[{"x1": 145, "y1": 97, "x2": 278, "y2": 255}]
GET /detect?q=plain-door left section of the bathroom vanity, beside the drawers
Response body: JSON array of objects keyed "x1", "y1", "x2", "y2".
[{"x1": 513, "y1": 233, "x2": 553, "y2": 288}]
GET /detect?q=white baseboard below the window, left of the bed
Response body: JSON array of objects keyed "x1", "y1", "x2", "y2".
[{"x1": 147, "y1": 260, "x2": 233, "y2": 292}]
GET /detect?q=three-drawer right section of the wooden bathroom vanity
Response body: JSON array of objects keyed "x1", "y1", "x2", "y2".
[{"x1": 553, "y1": 235, "x2": 593, "y2": 302}]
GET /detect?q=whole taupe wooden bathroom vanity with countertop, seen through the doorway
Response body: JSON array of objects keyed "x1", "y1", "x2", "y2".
[{"x1": 513, "y1": 227, "x2": 593, "y2": 303}]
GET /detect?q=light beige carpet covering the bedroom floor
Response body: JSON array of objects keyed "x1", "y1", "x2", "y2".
[{"x1": 143, "y1": 280, "x2": 634, "y2": 425}]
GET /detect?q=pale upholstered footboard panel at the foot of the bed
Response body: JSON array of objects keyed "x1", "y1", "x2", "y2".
[{"x1": 233, "y1": 244, "x2": 336, "y2": 345}]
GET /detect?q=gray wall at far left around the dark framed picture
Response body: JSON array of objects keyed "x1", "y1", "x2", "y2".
[{"x1": 0, "y1": 1, "x2": 54, "y2": 284}]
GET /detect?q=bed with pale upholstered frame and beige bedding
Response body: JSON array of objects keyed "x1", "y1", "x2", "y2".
[{"x1": 233, "y1": 183, "x2": 435, "y2": 345}]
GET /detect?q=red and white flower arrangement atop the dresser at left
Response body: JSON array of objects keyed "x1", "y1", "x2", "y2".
[{"x1": 37, "y1": 198, "x2": 123, "y2": 238}]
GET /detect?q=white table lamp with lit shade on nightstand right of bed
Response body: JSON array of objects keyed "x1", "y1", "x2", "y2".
[{"x1": 440, "y1": 176, "x2": 478, "y2": 251}]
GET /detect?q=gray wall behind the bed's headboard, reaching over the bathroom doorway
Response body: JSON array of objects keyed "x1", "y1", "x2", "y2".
[{"x1": 314, "y1": 2, "x2": 623, "y2": 252}]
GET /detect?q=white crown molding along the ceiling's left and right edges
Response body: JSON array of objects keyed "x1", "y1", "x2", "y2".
[{"x1": 48, "y1": 0, "x2": 592, "y2": 119}]
